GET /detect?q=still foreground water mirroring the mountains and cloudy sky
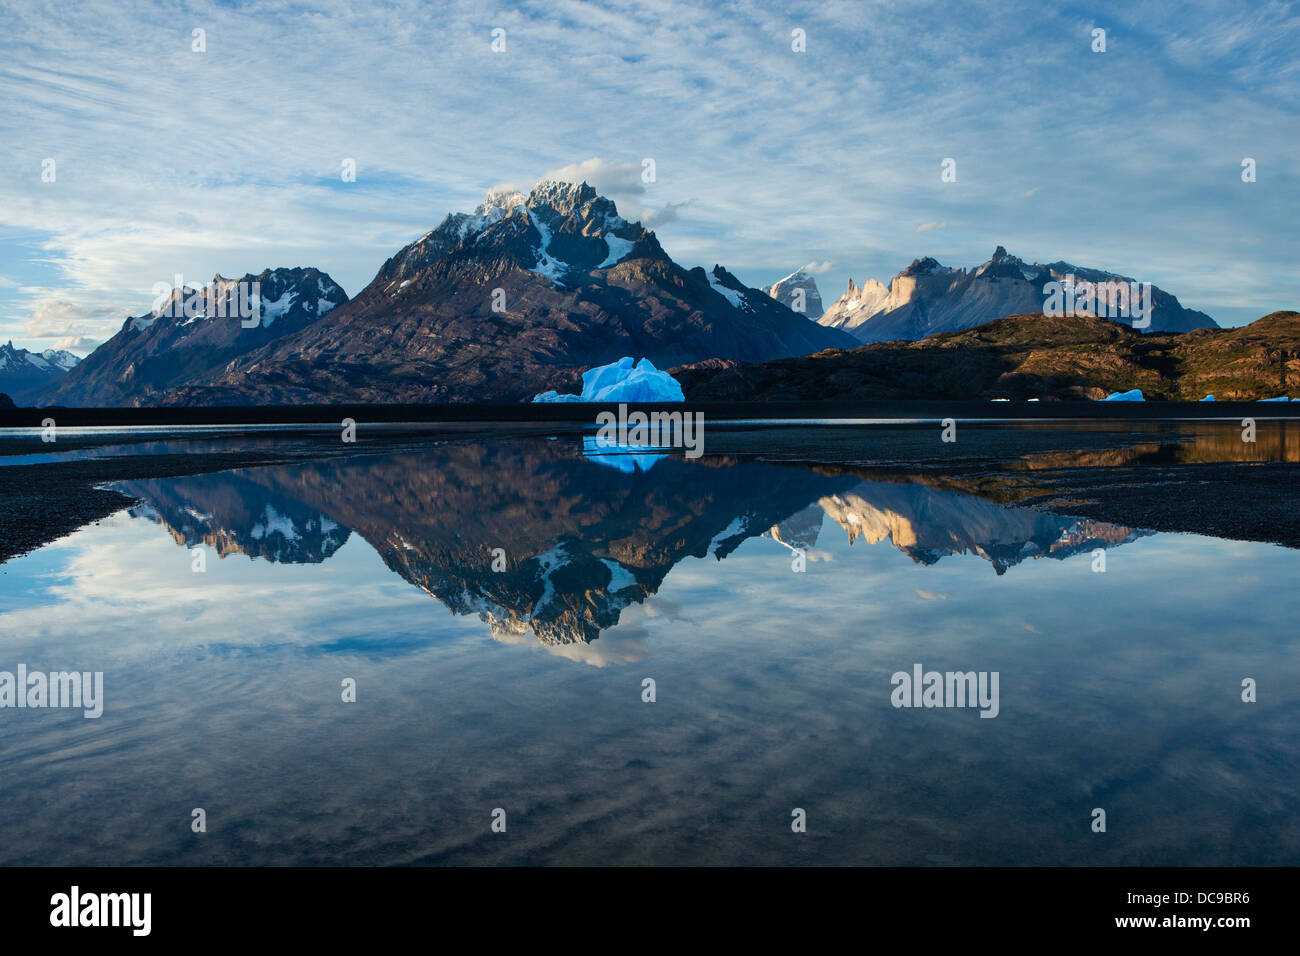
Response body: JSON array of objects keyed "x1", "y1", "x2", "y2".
[{"x1": 0, "y1": 437, "x2": 1300, "y2": 865}]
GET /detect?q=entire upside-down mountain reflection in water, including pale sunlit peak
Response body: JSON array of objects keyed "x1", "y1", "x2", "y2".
[{"x1": 114, "y1": 440, "x2": 1145, "y2": 644}]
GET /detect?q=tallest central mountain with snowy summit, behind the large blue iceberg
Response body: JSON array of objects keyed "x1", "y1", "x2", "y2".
[{"x1": 122, "y1": 182, "x2": 855, "y2": 405}]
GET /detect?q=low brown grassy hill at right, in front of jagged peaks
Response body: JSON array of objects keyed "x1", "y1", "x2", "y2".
[{"x1": 672, "y1": 312, "x2": 1300, "y2": 402}]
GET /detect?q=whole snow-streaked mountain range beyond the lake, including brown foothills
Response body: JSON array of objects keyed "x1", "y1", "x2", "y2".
[{"x1": 12, "y1": 182, "x2": 1290, "y2": 406}]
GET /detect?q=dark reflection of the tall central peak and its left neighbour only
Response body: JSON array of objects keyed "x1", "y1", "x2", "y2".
[{"x1": 113, "y1": 441, "x2": 855, "y2": 644}]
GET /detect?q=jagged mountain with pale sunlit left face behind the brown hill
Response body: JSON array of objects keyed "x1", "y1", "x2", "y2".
[{"x1": 818, "y1": 246, "x2": 1218, "y2": 342}]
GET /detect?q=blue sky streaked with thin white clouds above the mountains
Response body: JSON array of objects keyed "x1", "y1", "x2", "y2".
[{"x1": 0, "y1": 0, "x2": 1300, "y2": 354}]
